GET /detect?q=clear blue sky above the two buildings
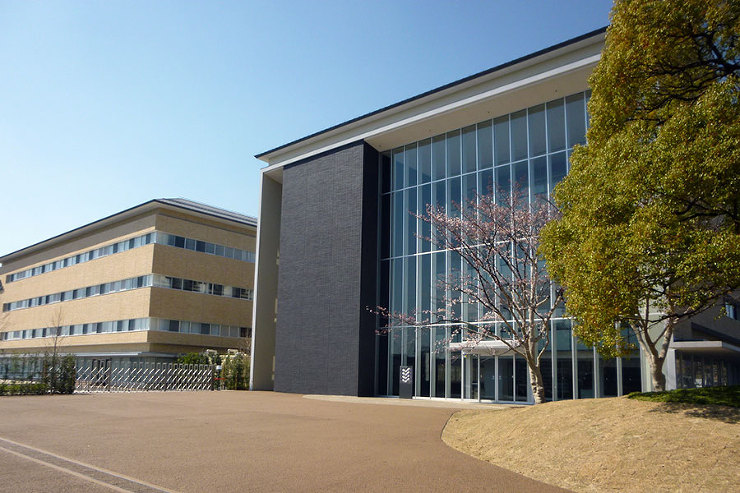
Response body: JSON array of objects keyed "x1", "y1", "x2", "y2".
[{"x1": 0, "y1": 0, "x2": 611, "y2": 254}]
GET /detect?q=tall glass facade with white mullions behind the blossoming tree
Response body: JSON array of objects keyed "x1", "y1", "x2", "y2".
[{"x1": 375, "y1": 92, "x2": 640, "y2": 402}]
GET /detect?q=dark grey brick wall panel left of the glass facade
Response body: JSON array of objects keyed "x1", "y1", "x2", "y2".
[{"x1": 275, "y1": 142, "x2": 378, "y2": 395}]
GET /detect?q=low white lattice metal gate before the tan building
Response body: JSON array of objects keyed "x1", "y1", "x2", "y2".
[{"x1": 75, "y1": 362, "x2": 216, "y2": 392}]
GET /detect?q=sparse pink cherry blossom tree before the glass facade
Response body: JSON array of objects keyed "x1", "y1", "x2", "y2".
[{"x1": 378, "y1": 189, "x2": 563, "y2": 403}]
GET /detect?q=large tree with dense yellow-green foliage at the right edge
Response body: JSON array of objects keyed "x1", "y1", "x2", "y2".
[{"x1": 542, "y1": 0, "x2": 740, "y2": 390}]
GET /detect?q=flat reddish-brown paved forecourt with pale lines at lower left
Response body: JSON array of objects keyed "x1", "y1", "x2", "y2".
[{"x1": 0, "y1": 392, "x2": 562, "y2": 492}]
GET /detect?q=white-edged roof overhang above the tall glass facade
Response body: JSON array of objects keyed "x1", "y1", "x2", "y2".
[{"x1": 256, "y1": 28, "x2": 606, "y2": 177}]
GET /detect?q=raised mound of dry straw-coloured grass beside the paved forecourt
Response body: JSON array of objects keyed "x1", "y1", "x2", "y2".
[{"x1": 442, "y1": 397, "x2": 740, "y2": 492}]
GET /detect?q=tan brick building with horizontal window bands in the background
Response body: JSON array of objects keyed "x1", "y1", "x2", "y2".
[{"x1": 0, "y1": 199, "x2": 256, "y2": 364}]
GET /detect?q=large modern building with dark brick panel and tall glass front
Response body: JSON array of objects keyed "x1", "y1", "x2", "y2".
[{"x1": 251, "y1": 29, "x2": 740, "y2": 402}]
